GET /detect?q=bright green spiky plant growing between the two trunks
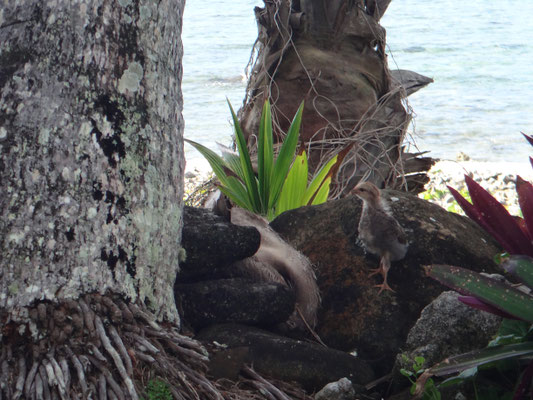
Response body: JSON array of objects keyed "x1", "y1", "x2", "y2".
[{"x1": 185, "y1": 101, "x2": 343, "y2": 220}]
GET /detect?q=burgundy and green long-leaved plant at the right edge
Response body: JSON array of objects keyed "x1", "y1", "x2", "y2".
[{"x1": 417, "y1": 134, "x2": 533, "y2": 400}]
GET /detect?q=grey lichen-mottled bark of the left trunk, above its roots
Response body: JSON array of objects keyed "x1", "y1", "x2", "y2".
[{"x1": 0, "y1": 0, "x2": 184, "y2": 322}]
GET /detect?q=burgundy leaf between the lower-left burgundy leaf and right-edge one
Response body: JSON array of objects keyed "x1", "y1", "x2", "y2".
[{"x1": 465, "y1": 175, "x2": 533, "y2": 257}]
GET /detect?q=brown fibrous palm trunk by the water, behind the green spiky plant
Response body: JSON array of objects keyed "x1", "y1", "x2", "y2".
[{"x1": 240, "y1": 0, "x2": 432, "y2": 197}]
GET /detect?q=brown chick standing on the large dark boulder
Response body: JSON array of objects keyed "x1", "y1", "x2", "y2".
[{"x1": 352, "y1": 182, "x2": 408, "y2": 293}]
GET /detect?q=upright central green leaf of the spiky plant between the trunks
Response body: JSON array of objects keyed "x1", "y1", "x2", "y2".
[{"x1": 257, "y1": 100, "x2": 274, "y2": 207}]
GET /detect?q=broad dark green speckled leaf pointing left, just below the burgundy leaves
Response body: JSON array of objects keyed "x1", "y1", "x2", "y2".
[{"x1": 425, "y1": 265, "x2": 533, "y2": 322}]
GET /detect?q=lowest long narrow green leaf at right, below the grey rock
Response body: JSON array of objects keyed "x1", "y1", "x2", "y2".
[{"x1": 428, "y1": 342, "x2": 533, "y2": 376}]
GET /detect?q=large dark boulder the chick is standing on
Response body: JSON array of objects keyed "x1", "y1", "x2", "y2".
[{"x1": 271, "y1": 190, "x2": 500, "y2": 375}]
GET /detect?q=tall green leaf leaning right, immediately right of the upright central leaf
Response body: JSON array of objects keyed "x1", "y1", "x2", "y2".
[{"x1": 268, "y1": 102, "x2": 304, "y2": 208}]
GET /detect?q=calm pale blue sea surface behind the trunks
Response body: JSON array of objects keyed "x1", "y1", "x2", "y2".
[{"x1": 182, "y1": 0, "x2": 533, "y2": 173}]
